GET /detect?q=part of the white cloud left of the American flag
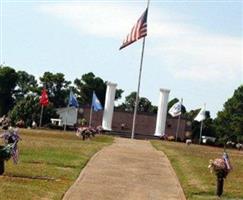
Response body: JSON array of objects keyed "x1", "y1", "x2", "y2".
[{"x1": 40, "y1": 2, "x2": 144, "y2": 38}]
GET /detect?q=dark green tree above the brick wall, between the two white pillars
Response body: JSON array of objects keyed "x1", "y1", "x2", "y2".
[{"x1": 119, "y1": 92, "x2": 157, "y2": 113}]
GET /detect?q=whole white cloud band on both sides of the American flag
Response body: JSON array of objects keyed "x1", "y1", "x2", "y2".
[{"x1": 40, "y1": 2, "x2": 243, "y2": 81}]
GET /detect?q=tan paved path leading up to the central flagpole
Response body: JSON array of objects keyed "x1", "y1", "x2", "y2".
[{"x1": 63, "y1": 138, "x2": 185, "y2": 200}]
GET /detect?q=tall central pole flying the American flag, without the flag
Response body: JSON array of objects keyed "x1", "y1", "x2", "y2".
[{"x1": 131, "y1": 0, "x2": 150, "y2": 139}]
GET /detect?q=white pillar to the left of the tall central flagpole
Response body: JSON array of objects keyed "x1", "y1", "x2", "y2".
[{"x1": 102, "y1": 82, "x2": 117, "y2": 131}]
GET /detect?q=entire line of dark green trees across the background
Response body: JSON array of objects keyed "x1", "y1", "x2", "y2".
[{"x1": 0, "y1": 66, "x2": 243, "y2": 142}]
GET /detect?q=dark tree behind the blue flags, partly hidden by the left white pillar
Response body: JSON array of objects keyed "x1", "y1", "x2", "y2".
[{"x1": 74, "y1": 72, "x2": 123, "y2": 105}]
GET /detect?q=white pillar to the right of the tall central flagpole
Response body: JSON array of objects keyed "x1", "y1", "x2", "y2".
[{"x1": 154, "y1": 89, "x2": 170, "y2": 137}]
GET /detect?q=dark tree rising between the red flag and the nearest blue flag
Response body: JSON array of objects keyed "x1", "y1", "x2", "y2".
[{"x1": 39, "y1": 72, "x2": 71, "y2": 108}]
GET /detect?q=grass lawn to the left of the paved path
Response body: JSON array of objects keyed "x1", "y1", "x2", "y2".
[{"x1": 0, "y1": 130, "x2": 113, "y2": 200}]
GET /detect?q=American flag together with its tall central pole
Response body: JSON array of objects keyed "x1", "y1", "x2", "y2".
[{"x1": 120, "y1": 0, "x2": 150, "y2": 139}]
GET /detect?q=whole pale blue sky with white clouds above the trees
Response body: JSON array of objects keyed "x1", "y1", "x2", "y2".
[{"x1": 0, "y1": 0, "x2": 243, "y2": 118}]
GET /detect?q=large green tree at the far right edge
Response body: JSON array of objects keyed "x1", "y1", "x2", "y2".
[{"x1": 214, "y1": 85, "x2": 243, "y2": 142}]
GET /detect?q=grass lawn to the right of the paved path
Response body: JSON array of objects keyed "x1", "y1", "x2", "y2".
[{"x1": 151, "y1": 141, "x2": 243, "y2": 200}]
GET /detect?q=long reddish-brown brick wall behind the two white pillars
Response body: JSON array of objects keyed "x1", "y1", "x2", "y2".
[{"x1": 79, "y1": 108, "x2": 189, "y2": 140}]
